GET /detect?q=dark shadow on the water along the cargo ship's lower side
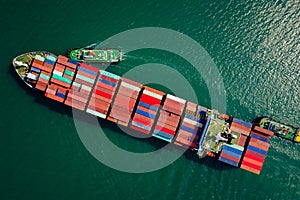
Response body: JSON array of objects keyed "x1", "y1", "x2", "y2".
[{"x1": 8, "y1": 66, "x2": 235, "y2": 170}]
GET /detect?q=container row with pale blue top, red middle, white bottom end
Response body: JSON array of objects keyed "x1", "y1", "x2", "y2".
[{"x1": 86, "y1": 70, "x2": 120, "y2": 119}]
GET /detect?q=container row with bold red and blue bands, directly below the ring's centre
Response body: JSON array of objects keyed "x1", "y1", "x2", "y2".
[{"x1": 130, "y1": 86, "x2": 165, "y2": 134}]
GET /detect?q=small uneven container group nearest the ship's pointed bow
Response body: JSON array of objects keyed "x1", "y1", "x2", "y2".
[{"x1": 30, "y1": 55, "x2": 57, "y2": 91}]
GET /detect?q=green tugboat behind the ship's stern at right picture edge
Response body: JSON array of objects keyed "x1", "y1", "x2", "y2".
[{"x1": 256, "y1": 117, "x2": 300, "y2": 142}]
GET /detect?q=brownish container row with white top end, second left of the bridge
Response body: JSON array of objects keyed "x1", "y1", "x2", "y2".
[{"x1": 152, "y1": 94, "x2": 186, "y2": 142}]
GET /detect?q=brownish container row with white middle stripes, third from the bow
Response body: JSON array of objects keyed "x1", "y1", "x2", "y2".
[{"x1": 65, "y1": 63, "x2": 99, "y2": 110}]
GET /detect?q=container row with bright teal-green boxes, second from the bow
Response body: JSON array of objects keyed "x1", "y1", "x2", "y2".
[{"x1": 45, "y1": 56, "x2": 77, "y2": 102}]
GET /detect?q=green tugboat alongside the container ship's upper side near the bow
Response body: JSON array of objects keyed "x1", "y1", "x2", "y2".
[{"x1": 67, "y1": 48, "x2": 122, "y2": 63}]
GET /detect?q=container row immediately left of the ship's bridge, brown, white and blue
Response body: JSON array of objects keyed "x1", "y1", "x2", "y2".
[{"x1": 174, "y1": 102, "x2": 207, "y2": 149}]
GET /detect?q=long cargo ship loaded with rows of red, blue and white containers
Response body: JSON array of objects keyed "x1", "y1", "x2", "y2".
[{"x1": 13, "y1": 52, "x2": 292, "y2": 174}]
